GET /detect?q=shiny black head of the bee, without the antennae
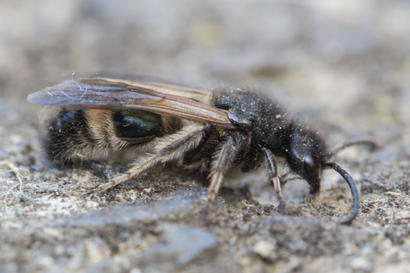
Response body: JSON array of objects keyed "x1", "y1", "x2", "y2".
[{"x1": 288, "y1": 129, "x2": 326, "y2": 193}]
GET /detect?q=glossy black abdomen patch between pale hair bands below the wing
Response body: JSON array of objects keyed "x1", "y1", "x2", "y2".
[{"x1": 114, "y1": 110, "x2": 162, "y2": 139}]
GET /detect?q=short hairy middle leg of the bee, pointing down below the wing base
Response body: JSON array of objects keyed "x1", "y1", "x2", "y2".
[{"x1": 207, "y1": 136, "x2": 239, "y2": 203}]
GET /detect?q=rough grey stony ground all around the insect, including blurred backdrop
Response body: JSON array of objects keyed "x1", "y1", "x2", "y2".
[{"x1": 0, "y1": 0, "x2": 410, "y2": 273}]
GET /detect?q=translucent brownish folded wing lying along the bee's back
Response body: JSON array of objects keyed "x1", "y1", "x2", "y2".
[{"x1": 27, "y1": 78, "x2": 234, "y2": 128}]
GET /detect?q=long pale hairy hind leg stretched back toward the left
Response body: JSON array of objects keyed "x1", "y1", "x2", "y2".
[{"x1": 87, "y1": 123, "x2": 205, "y2": 194}]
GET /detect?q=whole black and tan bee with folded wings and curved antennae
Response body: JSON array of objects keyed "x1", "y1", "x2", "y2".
[{"x1": 28, "y1": 77, "x2": 374, "y2": 224}]
